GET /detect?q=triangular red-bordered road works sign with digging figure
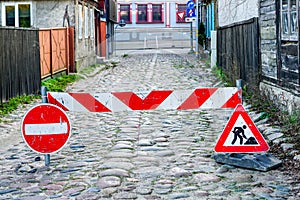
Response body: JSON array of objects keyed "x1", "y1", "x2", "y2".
[{"x1": 215, "y1": 104, "x2": 269, "y2": 153}]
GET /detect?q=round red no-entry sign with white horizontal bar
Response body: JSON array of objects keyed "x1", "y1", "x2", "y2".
[{"x1": 21, "y1": 104, "x2": 71, "y2": 154}]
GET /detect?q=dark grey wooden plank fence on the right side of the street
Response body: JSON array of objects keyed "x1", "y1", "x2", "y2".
[{"x1": 217, "y1": 18, "x2": 261, "y2": 90}]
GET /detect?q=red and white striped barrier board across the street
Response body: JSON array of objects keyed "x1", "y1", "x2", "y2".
[{"x1": 47, "y1": 87, "x2": 242, "y2": 112}]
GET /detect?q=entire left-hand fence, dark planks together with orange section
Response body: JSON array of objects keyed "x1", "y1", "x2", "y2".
[{"x1": 0, "y1": 27, "x2": 75, "y2": 104}]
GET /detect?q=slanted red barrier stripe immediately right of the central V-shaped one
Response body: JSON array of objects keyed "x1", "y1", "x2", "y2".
[{"x1": 177, "y1": 88, "x2": 217, "y2": 110}]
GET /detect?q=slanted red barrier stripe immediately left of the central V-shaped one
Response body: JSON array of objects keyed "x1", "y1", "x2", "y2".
[{"x1": 69, "y1": 93, "x2": 111, "y2": 112}]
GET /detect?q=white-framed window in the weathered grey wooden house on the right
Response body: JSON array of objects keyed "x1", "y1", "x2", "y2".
[{"x1": 281, "y1": 0, "x2": 298, "y2": 40}]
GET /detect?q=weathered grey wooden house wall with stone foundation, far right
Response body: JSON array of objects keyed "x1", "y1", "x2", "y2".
[{"x1": 259, "y1": 0, "x2": 300, "y2": 113}]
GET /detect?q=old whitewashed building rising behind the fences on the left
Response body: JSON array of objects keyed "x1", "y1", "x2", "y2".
[{"x1": 0, "y1": 0, "x2": 106, "y2": 69}]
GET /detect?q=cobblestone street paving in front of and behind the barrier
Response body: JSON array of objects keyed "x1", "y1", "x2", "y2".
[{"x1": 0, "y1": 50, "x2": 300, "y2": 200}]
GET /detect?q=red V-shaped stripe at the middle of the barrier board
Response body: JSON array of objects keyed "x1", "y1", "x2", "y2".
[{"x1": 112, "y1": 90, "x2": 173, "y2": 110}]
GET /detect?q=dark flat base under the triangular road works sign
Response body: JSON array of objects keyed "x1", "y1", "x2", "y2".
[{"x1": 213, "y1": 153, "x2": 282, "y2": 172}]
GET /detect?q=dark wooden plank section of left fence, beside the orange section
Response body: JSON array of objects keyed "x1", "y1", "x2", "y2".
[{"x1": 0, "y1": 27, "x2": 41, "y2": 103}]
